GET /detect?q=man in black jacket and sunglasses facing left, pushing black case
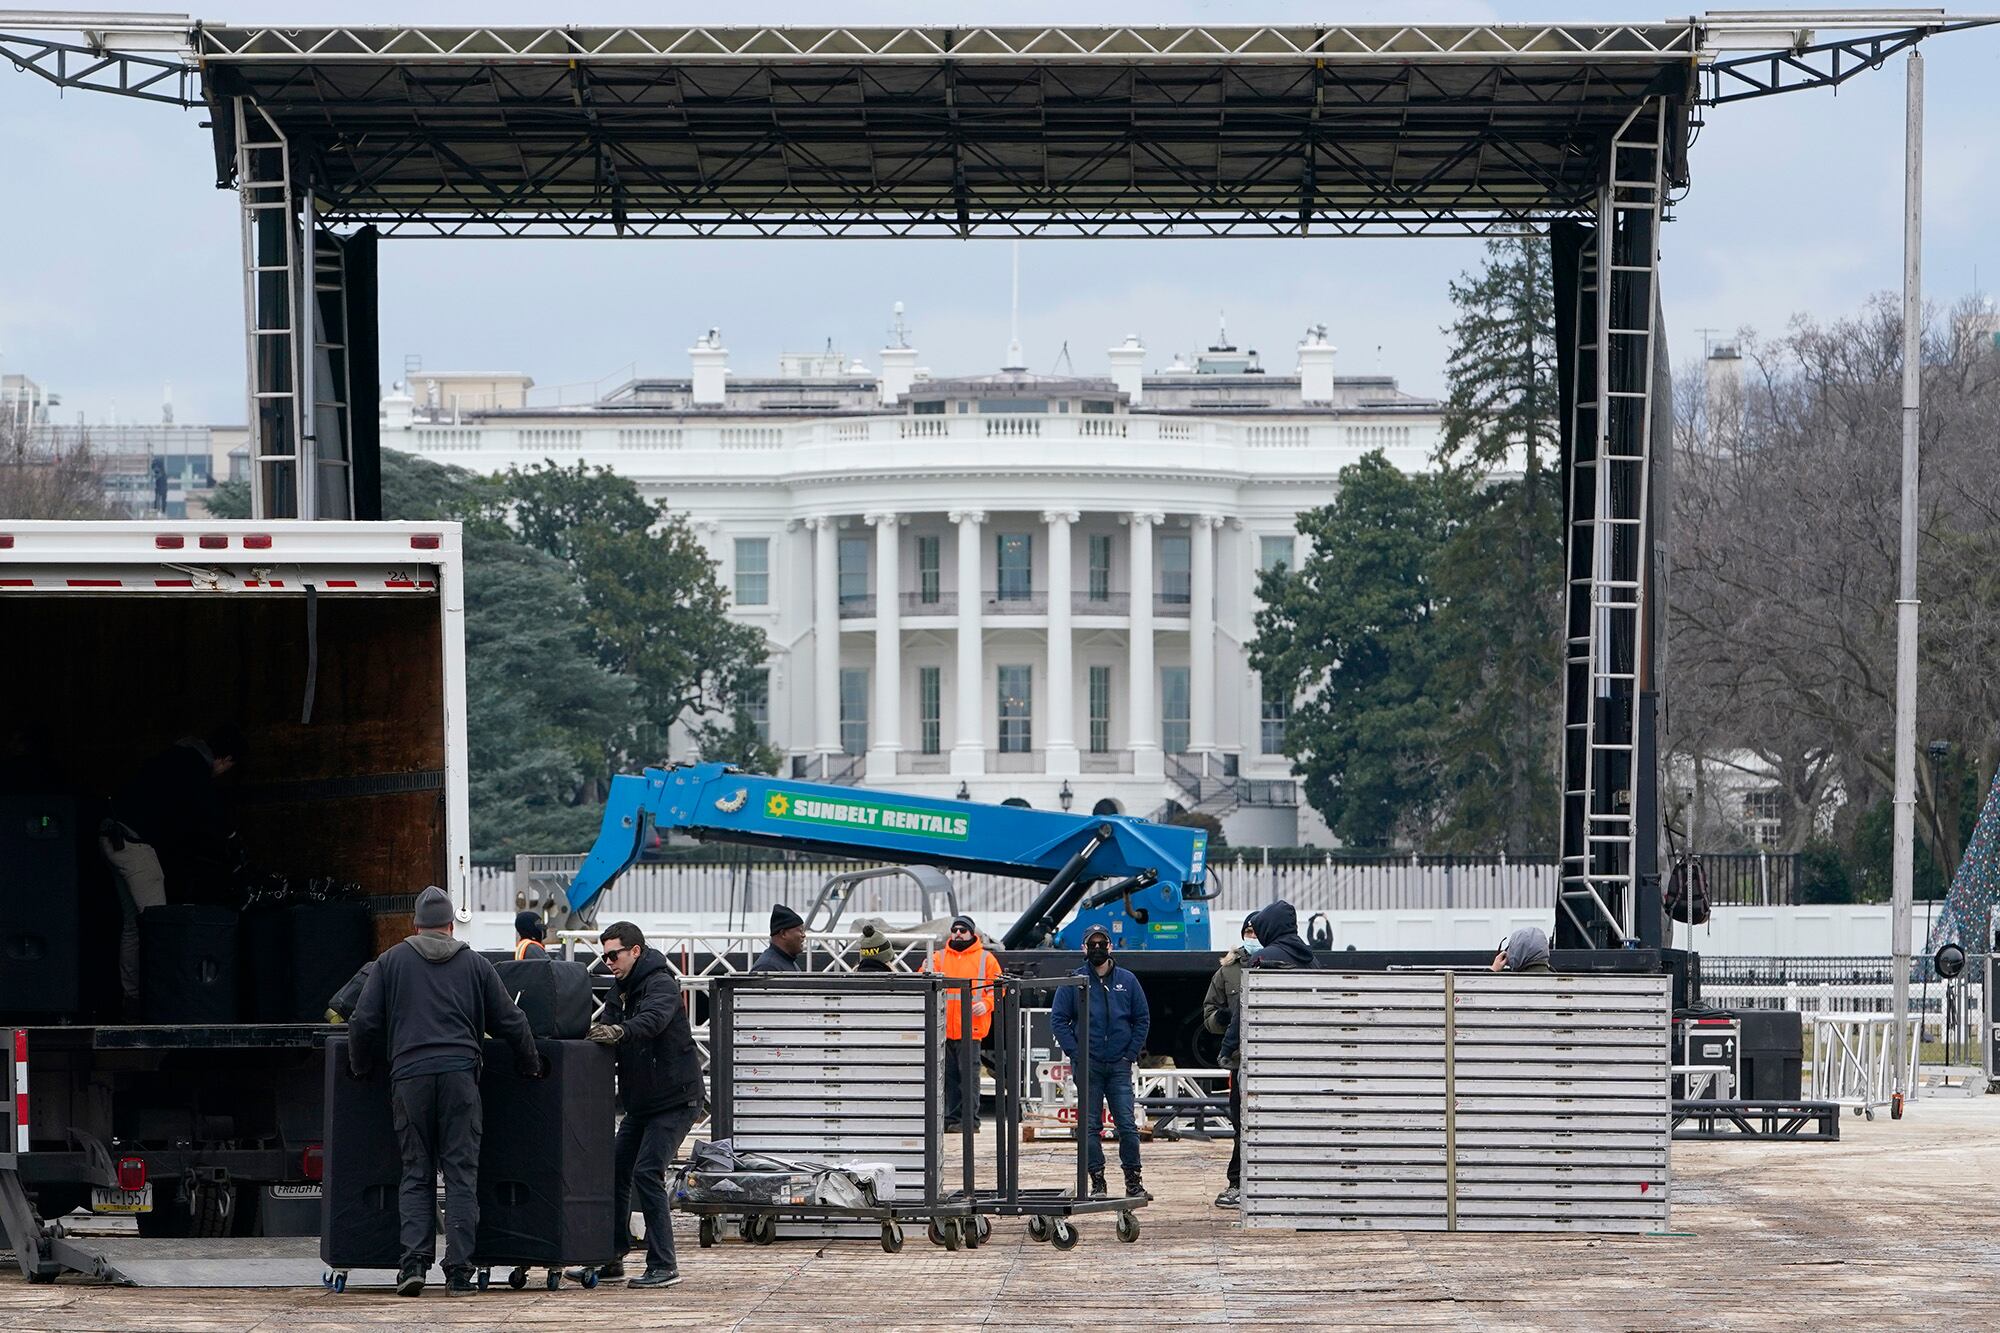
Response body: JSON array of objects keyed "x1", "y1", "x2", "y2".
[{"x1": 578, "y1": 921, "x2": 702, "y2": 1287}]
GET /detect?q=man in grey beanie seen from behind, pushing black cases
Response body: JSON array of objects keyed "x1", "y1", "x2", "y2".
[{"x1": 348, "y1": 887, "x2": 548, "y2": 1297}]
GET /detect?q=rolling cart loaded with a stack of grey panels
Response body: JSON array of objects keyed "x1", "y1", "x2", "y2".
[{"x1": 674, "y1": 973, "x2": 992, "y2": 1253}]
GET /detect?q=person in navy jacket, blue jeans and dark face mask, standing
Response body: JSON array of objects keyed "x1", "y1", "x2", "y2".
[{"x1": 1050, "y1": 927, "x2": 1152, "y2": 1197}]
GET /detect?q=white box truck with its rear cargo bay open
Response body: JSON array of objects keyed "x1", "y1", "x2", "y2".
[{"x1": 0, "y1": 520, "x2": 470, "y2": 1281}]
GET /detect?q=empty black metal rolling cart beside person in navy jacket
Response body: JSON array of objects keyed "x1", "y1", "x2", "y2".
[{"x1": 976, "y1": 975, "x2": 1148, "y2": 1249}]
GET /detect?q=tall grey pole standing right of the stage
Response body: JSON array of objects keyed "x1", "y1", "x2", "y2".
[{"x1": 1890, "y1": 50, "x2": 1924, "y2": 1117}]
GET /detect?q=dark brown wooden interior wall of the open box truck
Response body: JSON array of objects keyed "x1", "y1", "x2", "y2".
[{"x1": 0, "y1": 594, "x2": 446, "y2": 947}]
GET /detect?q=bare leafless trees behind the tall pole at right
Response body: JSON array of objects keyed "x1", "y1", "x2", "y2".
[{"x1": 1670, "y1": 296, "x2": 2000, "y2": 869}]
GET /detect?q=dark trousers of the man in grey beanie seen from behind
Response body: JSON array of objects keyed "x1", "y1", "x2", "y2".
[{"x1": 390, "y1": 1069, "x2": 480, "y2": 1271}]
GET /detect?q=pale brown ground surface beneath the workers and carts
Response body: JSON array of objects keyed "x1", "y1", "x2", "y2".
[{"x1": 0, "y1": 1097, "x2": 2000, "y2": 1333}]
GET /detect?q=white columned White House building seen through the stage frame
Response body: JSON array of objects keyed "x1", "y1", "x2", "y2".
[{"x1": 382, "y1": 316, "x2": 1438, "y2": 845}]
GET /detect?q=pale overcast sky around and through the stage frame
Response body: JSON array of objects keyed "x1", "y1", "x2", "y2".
[{"x1": 0, "y1": 0, "x2": 2000, "y2": 422}]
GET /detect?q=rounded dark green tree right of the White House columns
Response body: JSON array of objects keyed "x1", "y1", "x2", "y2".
[{"x1": 1250, "y1": 452, "x2": 1466, "y2": 847}]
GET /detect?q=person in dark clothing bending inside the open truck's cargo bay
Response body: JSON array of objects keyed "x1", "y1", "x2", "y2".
[{"x1": 98, "y1": 727, "x2": 244, "y2": 1009}]
